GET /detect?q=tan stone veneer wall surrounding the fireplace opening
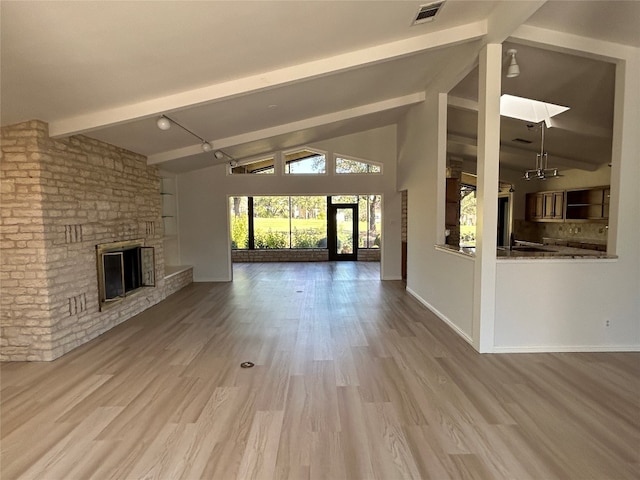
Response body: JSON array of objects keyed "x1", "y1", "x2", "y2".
[{"x1": 0, "y1": 121, "x2": 188, "y2": 361}]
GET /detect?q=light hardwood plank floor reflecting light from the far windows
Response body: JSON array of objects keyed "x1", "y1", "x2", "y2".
[{"x1": 0, "y1": 262, "x2": 640, "y2": 480}]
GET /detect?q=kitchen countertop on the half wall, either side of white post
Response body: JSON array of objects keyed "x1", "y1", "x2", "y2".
[{"x1": 436, "y1": 241, "x2": 618, "y2": 260}]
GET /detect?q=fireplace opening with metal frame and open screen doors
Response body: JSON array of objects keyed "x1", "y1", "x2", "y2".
[{"x1": 96, "y1": 240, "x2": 155, "y2": 309}]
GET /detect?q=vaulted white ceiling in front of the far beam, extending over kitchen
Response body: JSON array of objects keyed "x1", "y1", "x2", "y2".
[{"x1": 0, "y1": 0, "x2": 640, "y2": 171}]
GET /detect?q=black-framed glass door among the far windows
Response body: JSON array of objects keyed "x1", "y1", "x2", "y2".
[{"x1": 327, "y1": 203, "x2": 358, "y2": 260}]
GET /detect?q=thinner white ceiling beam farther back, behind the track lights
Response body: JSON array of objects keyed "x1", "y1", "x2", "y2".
[{"x1": 147, "y1": 92, "x2": 425, "y2": 165}]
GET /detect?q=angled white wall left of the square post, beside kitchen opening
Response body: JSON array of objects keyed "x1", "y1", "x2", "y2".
[{"x1": 398, "y1": 95, "x2": 474, "y2": 341}]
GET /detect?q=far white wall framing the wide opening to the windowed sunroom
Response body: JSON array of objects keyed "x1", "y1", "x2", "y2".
[{"x1": 178, "y1": 126, "x2": 401, "y2": 282}]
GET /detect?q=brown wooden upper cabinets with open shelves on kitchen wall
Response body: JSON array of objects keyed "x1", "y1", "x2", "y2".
[{"x1": 526, "y1": 186, "x2": 610, "y2": 222}]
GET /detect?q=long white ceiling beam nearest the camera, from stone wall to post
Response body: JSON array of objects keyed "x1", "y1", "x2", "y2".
[{"x1": 49, "y1": 21, "x2": 486, "y2": 137}]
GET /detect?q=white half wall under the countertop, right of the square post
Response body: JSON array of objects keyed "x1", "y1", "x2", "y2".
[{"x1": 494, "y1": 260, "x2": 639, "y2": 352}]
